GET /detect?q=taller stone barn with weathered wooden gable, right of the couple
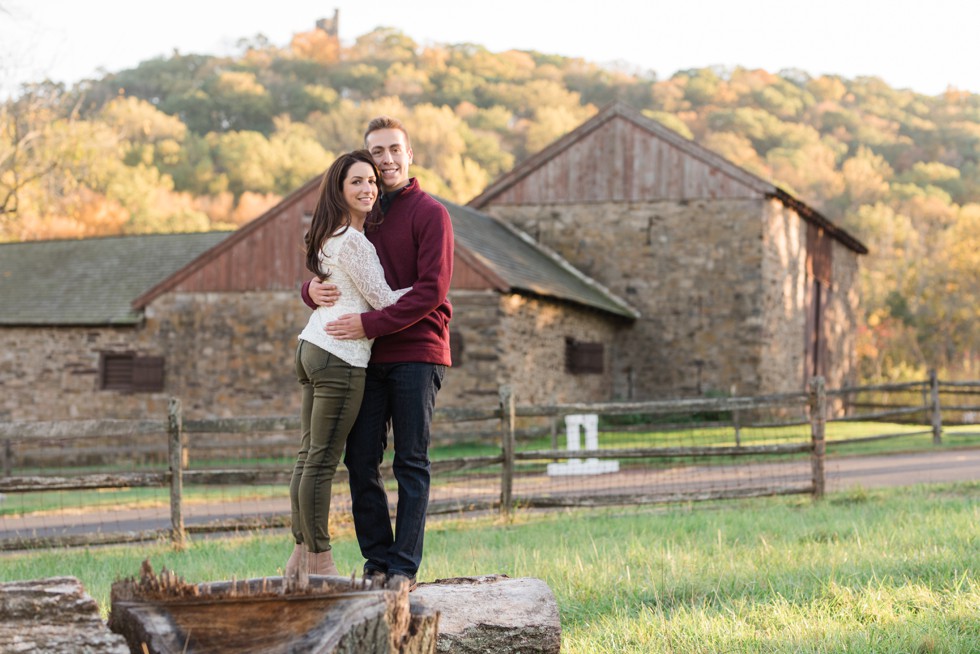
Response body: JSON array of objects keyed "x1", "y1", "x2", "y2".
[{"x1": 469, "y1": 103, "x2": 867, "y2": 400}]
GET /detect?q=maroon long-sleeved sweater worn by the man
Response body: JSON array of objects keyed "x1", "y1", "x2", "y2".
[{"x1": 303, "y1": 177, "x2": 453, "y2": 366}]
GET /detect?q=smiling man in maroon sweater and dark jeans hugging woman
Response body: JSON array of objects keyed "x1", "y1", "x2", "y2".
[{"x1": 303, "y1": 116, "x2": 453, "y2": 587}]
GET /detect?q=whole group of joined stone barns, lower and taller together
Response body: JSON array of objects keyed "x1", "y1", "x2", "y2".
[{"x1": 0, "y1": 103, "x2": 867, "y2": 420}]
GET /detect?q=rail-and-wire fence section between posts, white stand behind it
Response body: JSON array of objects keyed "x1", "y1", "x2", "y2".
[{"x1": 504, "y1": 394, "x2": 819, "y2": 507}]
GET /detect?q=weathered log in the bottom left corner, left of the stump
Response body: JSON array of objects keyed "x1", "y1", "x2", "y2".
[{"x1": 0, "y1": 577, "x2": 129, "y2": 654}]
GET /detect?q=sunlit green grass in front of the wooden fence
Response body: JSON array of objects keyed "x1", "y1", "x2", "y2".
[{"x1": 0, "y1": 483, "x2": 980, "y2": 654}]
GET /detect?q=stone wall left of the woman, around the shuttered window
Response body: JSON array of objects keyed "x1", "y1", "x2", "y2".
[{"x1": 0, "y1": 293, "x2": 309, "y2": 420}]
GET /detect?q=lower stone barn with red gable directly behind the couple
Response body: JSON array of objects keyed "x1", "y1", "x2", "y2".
[{"x1": 0, "y1": 179, "x2": 638, "y2": 420}]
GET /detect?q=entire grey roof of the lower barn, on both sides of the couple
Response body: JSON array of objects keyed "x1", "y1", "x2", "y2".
[{"x1": 0, "y1": 193, "x2": 639, "y2": 326}]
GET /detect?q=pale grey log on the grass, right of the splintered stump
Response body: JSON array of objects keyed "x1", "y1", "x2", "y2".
[{"x1": 412, "y1": 575, "x2": 561, "y2": 654}]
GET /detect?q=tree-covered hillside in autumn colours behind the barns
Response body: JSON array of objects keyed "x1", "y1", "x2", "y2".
[{"x1": 0, "y1": 28, "x2": 980, "y2": 381}]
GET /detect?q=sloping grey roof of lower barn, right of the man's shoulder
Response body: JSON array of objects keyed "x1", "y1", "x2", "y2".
[{"x1": 439, "y1": 199, "x2": 640, "y2": 319}]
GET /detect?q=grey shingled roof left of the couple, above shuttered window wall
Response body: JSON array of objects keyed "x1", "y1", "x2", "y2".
[{"x1": 0, "y1": 232, "x2": 231, "y2": 325}]
